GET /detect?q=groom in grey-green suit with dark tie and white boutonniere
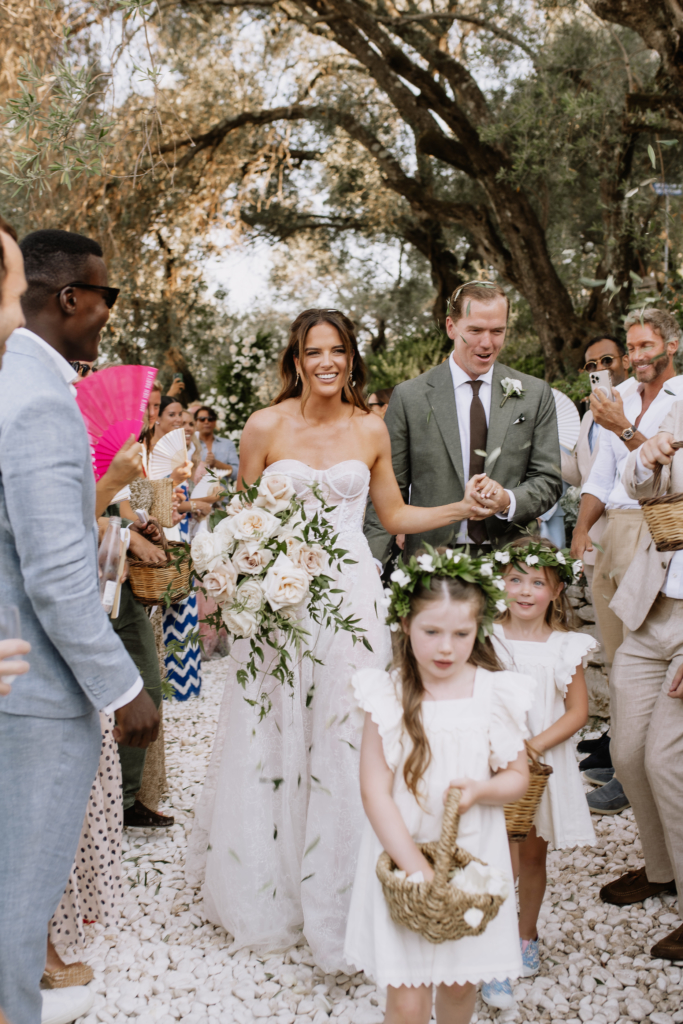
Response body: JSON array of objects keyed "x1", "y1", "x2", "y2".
[{"x1": 365, "y1": 282, "x2": 562, "y2": 563}]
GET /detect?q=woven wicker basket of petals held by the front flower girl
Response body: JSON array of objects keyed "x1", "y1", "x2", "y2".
[{"x1": 377, "y1": 790, "x2": 503, "y2": 944}]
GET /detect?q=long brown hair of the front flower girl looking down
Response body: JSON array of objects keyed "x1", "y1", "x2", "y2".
[{"x1": 398, "y1": 577, "x2": 503, "y2": 801}]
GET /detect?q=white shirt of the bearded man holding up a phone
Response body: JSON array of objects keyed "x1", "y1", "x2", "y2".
[{"x1": 581, "y1": 377, "x2": 683, "y2": 509}]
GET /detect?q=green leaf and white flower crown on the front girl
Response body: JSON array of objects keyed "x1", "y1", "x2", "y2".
[{"x1": 383, "y1": 544, "x2": 509, "y2": 641}]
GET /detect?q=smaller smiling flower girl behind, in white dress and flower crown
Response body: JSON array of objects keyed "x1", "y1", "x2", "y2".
[{"x1": 482, "y1": 538, "x2": 597, "y2": 1009}]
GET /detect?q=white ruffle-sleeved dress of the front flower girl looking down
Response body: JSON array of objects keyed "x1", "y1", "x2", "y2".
[{"x1": 344, "y1": 669, "x2": 533, "y2": 988}]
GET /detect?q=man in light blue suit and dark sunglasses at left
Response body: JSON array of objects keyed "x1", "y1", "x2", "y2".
[{"x1": 0, "y1": 231, "x2": 159, "y2": 1024}]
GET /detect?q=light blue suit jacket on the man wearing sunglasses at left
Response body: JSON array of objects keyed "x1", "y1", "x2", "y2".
[{"x1": 0, "y1": 334, "x2": 138, "y2": 718}]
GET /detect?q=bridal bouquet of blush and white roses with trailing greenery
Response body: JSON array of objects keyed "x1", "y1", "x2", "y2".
[{"x1": 191, "y1": 473, "x2": 372, "y2": 718}]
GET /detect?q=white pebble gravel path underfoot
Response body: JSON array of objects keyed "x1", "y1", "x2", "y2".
[{"x1": 67, "y1": 660, "x2": 683, "y2": 1024}]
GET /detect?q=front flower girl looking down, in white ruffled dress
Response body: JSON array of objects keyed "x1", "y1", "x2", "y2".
[{"x1": 344, "y1": 550, "x2": 532, "y2": 1024}]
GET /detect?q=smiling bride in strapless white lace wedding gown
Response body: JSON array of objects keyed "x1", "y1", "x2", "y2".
[{"x1": 187, "y1": 309, "x2": 488, "y2": 973}]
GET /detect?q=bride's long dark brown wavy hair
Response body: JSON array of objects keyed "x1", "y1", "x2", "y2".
[{"x1": 270, "y1": 309, "x2": 370, "y2": 413}]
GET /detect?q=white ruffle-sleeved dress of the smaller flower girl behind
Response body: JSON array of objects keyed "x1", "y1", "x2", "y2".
[{"x1": 494, "y1": 624, "x2": 598, "y2": 850}]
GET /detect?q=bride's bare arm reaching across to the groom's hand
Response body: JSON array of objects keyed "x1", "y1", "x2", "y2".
[{"x1": 370, "y1": 417, "x2": 490, "y2": 537}]
